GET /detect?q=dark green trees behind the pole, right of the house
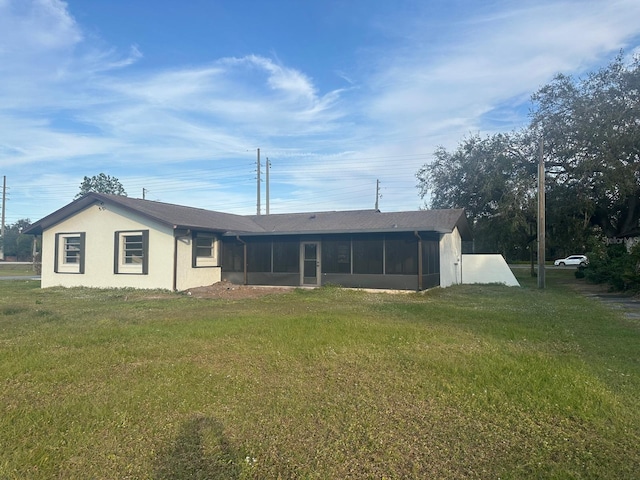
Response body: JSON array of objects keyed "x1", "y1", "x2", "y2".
[{"x1": 416, "y1": 53, "x2": 640, "y2": 288}]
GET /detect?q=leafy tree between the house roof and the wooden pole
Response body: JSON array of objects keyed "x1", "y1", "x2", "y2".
[{"x1": 417, "y1": 132, "x2": 537, "y2": 258}]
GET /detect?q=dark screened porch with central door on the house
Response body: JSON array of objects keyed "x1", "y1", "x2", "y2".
[{"x1": 222, "y1": 231, "x2": 440, "y2": 290}]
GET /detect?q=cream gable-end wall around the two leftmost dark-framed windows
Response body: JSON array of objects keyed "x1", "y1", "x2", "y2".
[{"x1": 41, "y1": 205, "x2": 176, "y2": 289}]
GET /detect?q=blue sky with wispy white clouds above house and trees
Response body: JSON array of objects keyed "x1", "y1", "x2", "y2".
[{"x1": 0, "y1": 0, "x2": 640, "y2": 224}]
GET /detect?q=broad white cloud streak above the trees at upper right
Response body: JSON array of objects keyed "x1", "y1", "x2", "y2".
[{"x1": 371, "y1": 0, "x2": 640, "y2": 144}]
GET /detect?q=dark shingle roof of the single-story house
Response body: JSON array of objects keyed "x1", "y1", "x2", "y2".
[{"x1": 25, "y1": 193, "x2": 470, "y2": 239}]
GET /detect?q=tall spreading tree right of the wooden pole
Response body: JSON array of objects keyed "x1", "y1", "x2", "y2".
[{"x1": 532, "y1": 55, "x2": 640, "y2": 237}]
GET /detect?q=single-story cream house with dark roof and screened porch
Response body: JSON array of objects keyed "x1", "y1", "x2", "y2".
[{"x1": 25, "y1": 193, "x2": 504, "y2": 290}]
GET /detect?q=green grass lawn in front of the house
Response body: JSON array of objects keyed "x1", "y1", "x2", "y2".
[{"x1": 0, "y1": 270, "x2": 640, "y2": 479}]
